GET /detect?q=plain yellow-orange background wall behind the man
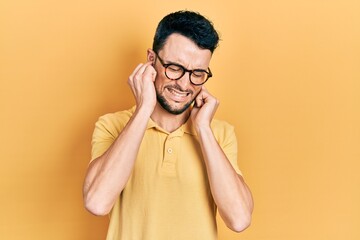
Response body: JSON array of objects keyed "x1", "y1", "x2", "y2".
[{"x1": 0, "y1": 0, "x2": 360, "y2": 240}]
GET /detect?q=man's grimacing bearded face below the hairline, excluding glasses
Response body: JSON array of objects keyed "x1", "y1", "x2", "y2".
[{"x1": 150, "y1": 34, "x2": 211, "y2": 114}]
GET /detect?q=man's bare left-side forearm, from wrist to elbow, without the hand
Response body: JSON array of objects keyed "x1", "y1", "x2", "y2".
[{"x1": 83, "y1": 107, "x2": 150, "y2": 215}]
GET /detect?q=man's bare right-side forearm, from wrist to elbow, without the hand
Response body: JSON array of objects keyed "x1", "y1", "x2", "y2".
[{"x1": 198, "y1": 127, "x2": 253, "y2": 232}]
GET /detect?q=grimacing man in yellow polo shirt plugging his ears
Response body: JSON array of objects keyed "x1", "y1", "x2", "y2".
[{"x1": 84, "y1": 11, "x2": 253, "y2": 240}]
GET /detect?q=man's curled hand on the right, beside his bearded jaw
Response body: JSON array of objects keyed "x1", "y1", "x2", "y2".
[{"x1": 191, "y1": 86, "x2": 220, "y2": 130}]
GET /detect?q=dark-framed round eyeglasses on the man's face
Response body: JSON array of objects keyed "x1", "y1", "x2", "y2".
[{"x1": 156, "y1": 54, "x2": 212, "y2": 86}]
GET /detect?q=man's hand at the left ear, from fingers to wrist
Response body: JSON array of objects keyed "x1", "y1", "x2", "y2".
[{"x1": 128, "y1": 62, "x2": 156, "y2": 114}]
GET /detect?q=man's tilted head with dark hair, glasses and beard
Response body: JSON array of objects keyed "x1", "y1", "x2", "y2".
[{"x1": 148, "y1": 11, "x2": 219, "y2": 114}]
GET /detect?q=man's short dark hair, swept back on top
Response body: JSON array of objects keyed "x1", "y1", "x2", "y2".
[{"x1": 153, "y1": 11, "x2": 219, "y2": 53}]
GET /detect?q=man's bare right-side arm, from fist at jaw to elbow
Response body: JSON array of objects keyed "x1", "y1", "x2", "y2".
[{"x1": 191, "y1": 87, "x2": 253, "y2": 232}]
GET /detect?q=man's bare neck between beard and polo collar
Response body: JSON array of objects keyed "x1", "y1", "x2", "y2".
[{"x1": 151, "y1": 104, "x2": 190, "y2": 133}]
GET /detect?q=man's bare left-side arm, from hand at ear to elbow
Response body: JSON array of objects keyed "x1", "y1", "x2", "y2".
[{"x1": 83, "y1": 62, "x2": 156, "y2": 215}]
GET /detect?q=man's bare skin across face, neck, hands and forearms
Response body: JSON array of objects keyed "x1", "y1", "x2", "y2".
[{"x1": 83, "y1": 34, "x2": 253, "y2": 232}]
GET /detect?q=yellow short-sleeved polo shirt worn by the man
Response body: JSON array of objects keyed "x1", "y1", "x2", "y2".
[{"x1": 92, "y1": 107, "x2": 241, "y2": 240}]
